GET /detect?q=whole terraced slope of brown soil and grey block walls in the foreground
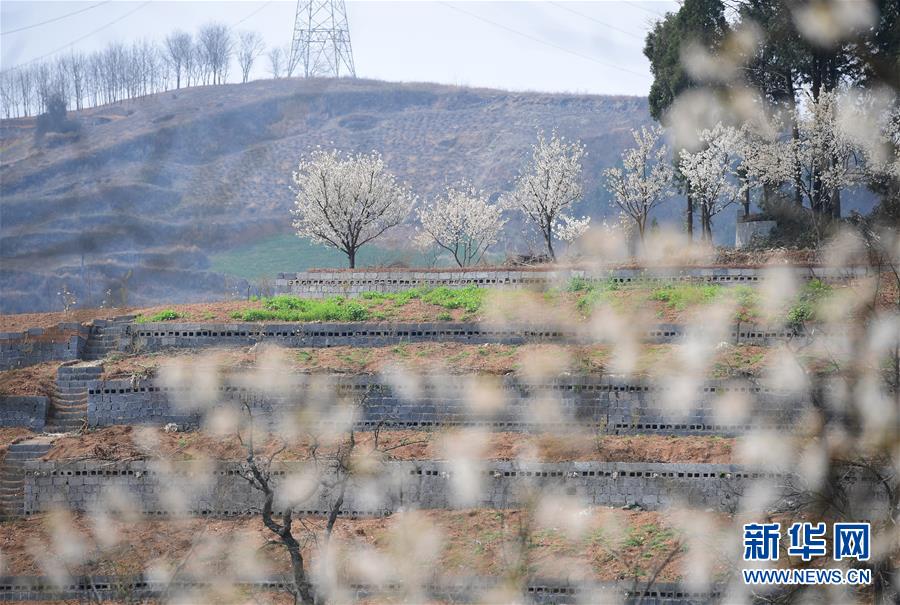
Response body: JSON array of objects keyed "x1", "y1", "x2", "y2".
[{"x1": 0, "y1": 267, "x2": 898, "y2": 605}]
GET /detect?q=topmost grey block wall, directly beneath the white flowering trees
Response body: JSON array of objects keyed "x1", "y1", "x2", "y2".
[{"x1": 275, "y1": 267, "x2": 865, "y2": 298}]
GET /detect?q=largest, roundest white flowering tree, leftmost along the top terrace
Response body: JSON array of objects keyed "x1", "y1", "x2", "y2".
[{"x1": 292, "y1": 150, "x2": 415, "y2": 268}]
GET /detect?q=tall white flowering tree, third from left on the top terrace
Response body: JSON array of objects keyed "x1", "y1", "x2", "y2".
[{"x1": 504, "y1": 132, "x2": 590, "y2": 260}]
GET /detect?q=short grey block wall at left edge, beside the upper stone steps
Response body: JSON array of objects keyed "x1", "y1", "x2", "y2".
[{"x1": 0, "y1": 323, "x2": 90, "y2": 371}]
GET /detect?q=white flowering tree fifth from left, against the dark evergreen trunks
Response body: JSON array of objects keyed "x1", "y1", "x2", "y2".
[{"x1": 679, "y1": 123, "x2": 747, "y2": 241}]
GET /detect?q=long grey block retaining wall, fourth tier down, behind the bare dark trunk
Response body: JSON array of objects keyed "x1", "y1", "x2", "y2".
[{"x1": 24, "y1": 461, "x2": 768, "y2": 517}]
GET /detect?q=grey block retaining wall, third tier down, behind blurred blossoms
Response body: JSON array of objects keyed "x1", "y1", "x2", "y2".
[{"x1": 88, "y1": 375, "x2": 807, "y2": 435}]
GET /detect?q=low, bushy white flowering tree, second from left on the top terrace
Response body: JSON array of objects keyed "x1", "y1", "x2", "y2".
[{"x1": 418, "y1": 186, "x2": 506, "y2": 267}]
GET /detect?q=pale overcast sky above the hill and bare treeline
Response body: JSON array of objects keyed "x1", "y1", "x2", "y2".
[{"x1": 0, "y1": 0, "x2": 677, "y2": 95}]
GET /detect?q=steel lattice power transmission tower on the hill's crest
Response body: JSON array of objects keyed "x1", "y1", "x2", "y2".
[{"x1": 288, "y1": 0, "x2": 356, "y2": 78}]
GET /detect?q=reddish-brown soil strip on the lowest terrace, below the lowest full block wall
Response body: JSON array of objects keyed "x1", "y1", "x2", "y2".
[{"x1": 0, "y1": 508, "x2": 704, "y2": 581}]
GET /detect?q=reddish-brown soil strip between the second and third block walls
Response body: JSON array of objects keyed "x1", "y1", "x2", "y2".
[{"x1": 98, "y1": 343, "x2": 771, "y2": 379}]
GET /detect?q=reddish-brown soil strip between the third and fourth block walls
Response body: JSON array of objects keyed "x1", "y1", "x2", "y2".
[{"x1": 44, "y1": 426, "x2": 734, "y2": 463}]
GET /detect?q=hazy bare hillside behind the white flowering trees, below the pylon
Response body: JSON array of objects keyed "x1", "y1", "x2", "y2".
[{"x1": 0, "y1": 80, "x2": 660, "y2": 313}]
